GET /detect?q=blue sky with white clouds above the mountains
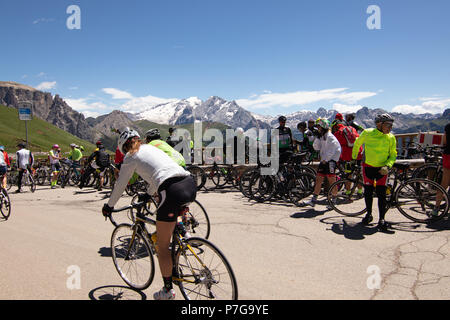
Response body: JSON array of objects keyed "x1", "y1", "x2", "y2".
[{"x1": 0, "y1": 0, "x2": 450, "y2": 115}]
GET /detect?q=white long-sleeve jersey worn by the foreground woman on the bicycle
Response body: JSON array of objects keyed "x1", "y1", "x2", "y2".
[{"x1": 108, "y1": 144, "x2": 190, "y2": 207}]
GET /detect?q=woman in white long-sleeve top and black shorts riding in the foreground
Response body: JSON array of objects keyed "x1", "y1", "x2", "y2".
[{"x1": 102, "y1": 129, "x2": 197, "y2": 300}]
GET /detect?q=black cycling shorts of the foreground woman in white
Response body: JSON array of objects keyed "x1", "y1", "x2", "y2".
[{"x1": 156, "y1": 176, "x2": 197, "y2": 222}]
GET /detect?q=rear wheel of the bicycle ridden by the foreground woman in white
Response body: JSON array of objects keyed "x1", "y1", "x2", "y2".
[{"x1": 174, "y1": 238, "x2": 238, "y2": 300}]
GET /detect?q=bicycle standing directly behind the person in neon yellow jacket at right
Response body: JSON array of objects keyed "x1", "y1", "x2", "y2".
[{"x1": 327, "y1": 163, "x2": 450, "y2": 223}]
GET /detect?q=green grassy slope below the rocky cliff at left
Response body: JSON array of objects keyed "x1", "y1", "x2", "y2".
[{"x1": 0, "y1": 105, "x2": 95, "y2": 155}]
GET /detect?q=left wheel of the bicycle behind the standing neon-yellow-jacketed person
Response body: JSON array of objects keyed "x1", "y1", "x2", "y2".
[{"x1": 327, "y1": 179, "x2": 367, "y2": 217}]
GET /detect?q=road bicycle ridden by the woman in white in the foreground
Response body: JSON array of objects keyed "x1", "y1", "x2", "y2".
[{"x1": 107, "y1": 202, "x2": 238, "y2": 300}]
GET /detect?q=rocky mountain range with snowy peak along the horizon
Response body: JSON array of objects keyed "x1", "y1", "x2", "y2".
[{"x1": 0, "y1": 81, "x2": 450, "y2": 149}]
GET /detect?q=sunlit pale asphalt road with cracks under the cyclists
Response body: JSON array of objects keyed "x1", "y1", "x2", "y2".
[{"x1": 0, "y1": 186, "x2": 450, "y2": 300}]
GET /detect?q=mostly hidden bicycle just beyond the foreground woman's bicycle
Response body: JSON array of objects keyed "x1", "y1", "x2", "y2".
[{"x1": 109, "y1": 193, "x2": 211, "y2": 239}]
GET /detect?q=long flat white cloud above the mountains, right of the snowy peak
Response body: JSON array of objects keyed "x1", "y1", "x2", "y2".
[{"x1": 236, "y1": 88, "x2": 377, "y2": 109}]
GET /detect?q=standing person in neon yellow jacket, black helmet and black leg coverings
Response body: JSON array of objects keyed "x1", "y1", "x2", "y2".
[{"x1": 352, "y1": 113, "x2": 397, "y2": 231}]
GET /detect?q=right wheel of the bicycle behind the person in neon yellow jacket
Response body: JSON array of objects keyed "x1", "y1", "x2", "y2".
[{"x1": 394, "y1": 178, "x2": 450, "y2": 223}]
